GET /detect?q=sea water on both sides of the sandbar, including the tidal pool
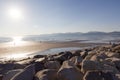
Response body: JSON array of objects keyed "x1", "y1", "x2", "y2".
[{"x1": 0, "y1": 34, "x2": 120, "y2": 60}]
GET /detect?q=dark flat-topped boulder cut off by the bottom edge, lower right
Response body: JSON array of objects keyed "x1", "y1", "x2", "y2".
[{"x1": 83, "y1": 71, "x2": 117, "y2": 80}]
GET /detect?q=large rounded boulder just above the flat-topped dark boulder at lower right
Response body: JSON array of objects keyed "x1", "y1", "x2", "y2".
[{"x1": 81, "y1": 60, "x2": 103, "y2": 73}]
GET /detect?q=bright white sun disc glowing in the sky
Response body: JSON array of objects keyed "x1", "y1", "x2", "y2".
[{"x1": 8, "y1": 7, "x2": 23, "y2": 19}]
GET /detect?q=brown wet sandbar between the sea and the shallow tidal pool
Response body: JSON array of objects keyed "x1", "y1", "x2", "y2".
[{"x1": 0, "y1": 41, "x2": 103, "y2": 56}]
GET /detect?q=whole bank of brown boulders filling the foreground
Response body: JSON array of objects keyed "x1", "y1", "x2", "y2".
[{"x1": 0, "y1": 44, "x2": 120, "y2": 80}]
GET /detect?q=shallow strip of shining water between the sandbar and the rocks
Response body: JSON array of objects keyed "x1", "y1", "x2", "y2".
[{"x1": 0, "y1": 47, "x2": 84, "y2": 61}]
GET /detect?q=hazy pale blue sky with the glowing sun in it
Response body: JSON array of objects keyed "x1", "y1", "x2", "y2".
[{"x1": 0, "y1": 0, "x2": 120, "y2": 36}]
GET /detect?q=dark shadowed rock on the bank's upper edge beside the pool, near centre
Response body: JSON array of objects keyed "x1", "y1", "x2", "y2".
[{"x1": 54, "y1": 51, "x2": 73, "y2": 64}]
